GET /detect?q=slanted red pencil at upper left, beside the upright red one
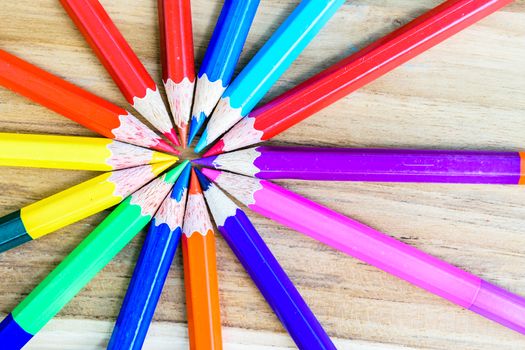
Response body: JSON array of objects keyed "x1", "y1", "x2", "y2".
[{"x1": 60, "y1": 0, "x2": 180, "y2": 146}]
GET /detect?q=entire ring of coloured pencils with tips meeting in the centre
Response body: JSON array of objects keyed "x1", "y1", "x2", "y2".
[{"x1": 0, "y1": 0, "x2": 525, "y2": 350}]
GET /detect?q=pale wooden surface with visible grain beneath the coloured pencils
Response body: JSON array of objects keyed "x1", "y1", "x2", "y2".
[{"x1": 0, "y1": 0, "x2": 525, "y2": 349}]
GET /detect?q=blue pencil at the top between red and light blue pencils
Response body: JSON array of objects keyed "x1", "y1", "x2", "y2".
[{"x1": 188, "y1": 0, "x2": 260, "y2": 145}]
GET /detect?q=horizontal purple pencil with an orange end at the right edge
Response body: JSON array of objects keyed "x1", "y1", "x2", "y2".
[{"x1": 193, "y1": 146, "x2": 525, "y2": 184}]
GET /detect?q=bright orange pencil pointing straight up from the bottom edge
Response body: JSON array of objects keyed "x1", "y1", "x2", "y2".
[{"x1": 182, "y1": 170, "x2": 222, "y2": 350}]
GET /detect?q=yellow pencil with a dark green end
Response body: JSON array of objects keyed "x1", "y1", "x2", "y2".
[{"x1": 0, "y1": 162, "x2": 173, "y2": 252}]
